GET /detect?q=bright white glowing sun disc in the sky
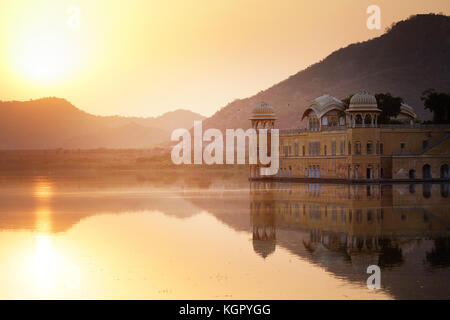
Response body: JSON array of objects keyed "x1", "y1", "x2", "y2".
[{"x1": 19, "y1": 37, "x2": 73, "y2": 82}]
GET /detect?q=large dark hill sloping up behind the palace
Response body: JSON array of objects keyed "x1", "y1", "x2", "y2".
[{"x1": 203, "y1": 14, "x2": 450, "y2": 129}]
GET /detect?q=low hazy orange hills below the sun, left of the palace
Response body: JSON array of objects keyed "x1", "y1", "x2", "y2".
[{"x1": 0, "y1": 98, "x2": 204, "y2": 149}]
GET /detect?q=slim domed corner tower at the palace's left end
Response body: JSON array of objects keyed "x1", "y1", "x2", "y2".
[{"x1": 249, "y1": 102, "x2": 277, "y2": 179}]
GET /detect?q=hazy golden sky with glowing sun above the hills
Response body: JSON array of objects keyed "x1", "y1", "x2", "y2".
[{"x1": 0, "y1": 0, "x2": 450, "y2": 116}]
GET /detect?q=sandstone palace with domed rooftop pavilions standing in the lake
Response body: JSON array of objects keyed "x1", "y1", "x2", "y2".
[{"x1": 250, "y1": 91, "x2": 450, "y2": 182}]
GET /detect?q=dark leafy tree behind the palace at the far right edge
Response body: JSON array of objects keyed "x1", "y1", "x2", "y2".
[{"x1": 420, "y1": 89, "x2": 450, "y2": 123}]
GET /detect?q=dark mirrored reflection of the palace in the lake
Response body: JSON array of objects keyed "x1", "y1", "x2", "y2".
[{"x1": 250, "y1": 182, "x2": 450, "y2": 298}]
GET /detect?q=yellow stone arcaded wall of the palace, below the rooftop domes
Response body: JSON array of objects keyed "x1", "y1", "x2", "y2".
[{"x1": 279, "y1": 128, "x2": 450, "y2": 179}]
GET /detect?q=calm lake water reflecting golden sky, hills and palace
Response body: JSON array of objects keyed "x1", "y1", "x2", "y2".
[{"x1": 0, "y1": 175, "x2": 450, "y2": 299}]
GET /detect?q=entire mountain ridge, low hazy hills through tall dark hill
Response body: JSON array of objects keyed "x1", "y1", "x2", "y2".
[{"x1": 0, "y1": 14, "x2": 450, "y2": 149}]
